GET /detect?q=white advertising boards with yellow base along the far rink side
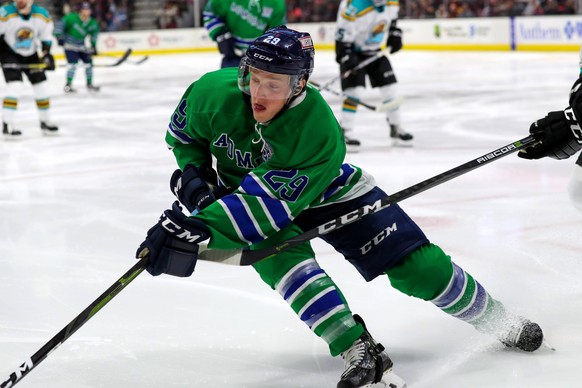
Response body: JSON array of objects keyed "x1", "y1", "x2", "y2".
[{"x1": 69, "y1": 15, "x2": 582, "y2": 55}]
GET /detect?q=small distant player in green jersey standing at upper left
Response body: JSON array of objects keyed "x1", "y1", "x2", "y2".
[{"x1": 55, "y1": 2, "x2": 99, "y2": 93}]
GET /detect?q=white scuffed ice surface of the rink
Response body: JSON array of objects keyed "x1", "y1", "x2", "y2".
[{"x1": 0, "y1": 50, "x2": 582, "y2": 388}]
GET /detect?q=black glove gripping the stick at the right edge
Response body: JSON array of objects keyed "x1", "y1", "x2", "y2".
[{"x1": 517, "y1": 107, "x2": 582, "y2": 159}]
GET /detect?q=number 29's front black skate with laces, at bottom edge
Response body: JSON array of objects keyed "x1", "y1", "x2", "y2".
[{"x1": 337, "y1": 315, "x2": 406, "y2": 388}]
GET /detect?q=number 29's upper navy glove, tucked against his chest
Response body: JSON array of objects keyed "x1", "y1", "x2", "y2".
[{"x1": 170, "y1": 164, "x2": 221, "y2": 213}]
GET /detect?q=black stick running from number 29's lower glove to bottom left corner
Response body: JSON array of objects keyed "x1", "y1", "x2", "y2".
[{"x1": 0, "y1": 256, "x2": 148, "y2": 388}]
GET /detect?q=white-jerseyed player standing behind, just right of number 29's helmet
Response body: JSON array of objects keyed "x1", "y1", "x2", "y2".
[{"x1": 335, "y1": 0, "x2": 412, "y2": 151}]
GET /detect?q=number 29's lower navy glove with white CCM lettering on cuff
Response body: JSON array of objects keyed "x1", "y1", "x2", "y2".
[{"x1": 135, "y1": 201, "x2": 210, "y2": 277}]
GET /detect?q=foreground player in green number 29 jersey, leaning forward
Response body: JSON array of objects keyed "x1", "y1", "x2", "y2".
[{"x1": 136, "y1": 26, "x2": 543, "y2": 388}]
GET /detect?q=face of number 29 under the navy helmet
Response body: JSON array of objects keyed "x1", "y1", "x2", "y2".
[{"x1": 249, "y1": 68, "x2": 291, "y2": 122}]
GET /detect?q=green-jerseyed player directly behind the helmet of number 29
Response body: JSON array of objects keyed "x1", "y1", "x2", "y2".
[{"x1": 204, "y1": 0, "x2": 287, "y2": 68}]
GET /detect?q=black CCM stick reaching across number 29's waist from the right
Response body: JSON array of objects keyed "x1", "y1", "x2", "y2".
[{"x1": 199, "y1": 136, "x2": 536, "y2": 266}]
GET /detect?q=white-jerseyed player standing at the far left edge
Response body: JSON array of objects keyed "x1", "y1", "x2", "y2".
[{"x1": 0, "y1": 0, "x2": 58, "y2": 137}]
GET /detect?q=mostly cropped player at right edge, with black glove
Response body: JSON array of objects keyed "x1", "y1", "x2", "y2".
[{"x1": 518, "y1": 49, "x2": 582, "y2": 211}]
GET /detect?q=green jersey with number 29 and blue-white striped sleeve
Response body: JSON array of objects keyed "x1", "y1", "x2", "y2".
[{"x1": 166, "y1": 68, "x2": 374, "y2": 249}]
